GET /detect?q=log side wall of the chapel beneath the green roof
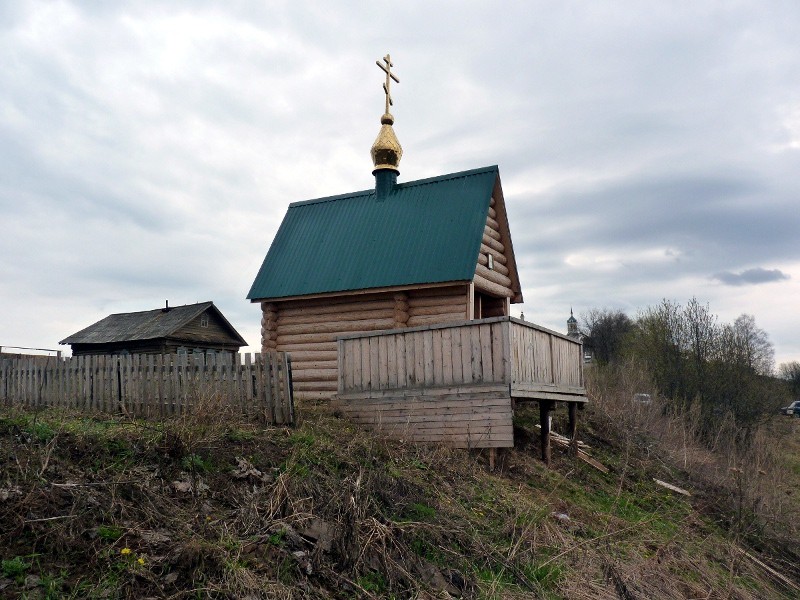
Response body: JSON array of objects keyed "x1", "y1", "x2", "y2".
[{"x1": 261, "y1": 285, "x2": 467, "y2": 401}]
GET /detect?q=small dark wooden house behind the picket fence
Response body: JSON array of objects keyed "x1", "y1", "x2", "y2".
[{"x1": 59, "y1": 302, "x2": 247, "y2": 356}]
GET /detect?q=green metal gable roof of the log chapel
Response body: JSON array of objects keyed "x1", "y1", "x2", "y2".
[{"x1": 247, "y1": 166, "x2": 498, "y2": 300}]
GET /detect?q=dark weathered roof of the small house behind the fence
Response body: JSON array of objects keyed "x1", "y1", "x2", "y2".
[{"x1": 59, "y1": 302, "x2": 247, "y2": 346}]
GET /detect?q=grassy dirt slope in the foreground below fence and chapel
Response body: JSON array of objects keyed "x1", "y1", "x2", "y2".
[{"x1": 0, "y1": 400, "x2": 800, "y2": 599}]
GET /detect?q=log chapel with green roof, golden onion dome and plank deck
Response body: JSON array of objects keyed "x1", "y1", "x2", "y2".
[{"x1": 247, "y1": 56, "x2": 585, "y2": 454}]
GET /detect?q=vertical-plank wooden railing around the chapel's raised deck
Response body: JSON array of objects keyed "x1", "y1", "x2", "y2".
[{"x1": 338, "y1": 317, "x2": 584, "y2": 400}]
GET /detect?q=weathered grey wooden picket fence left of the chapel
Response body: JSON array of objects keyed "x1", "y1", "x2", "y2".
[{"x1": 0, "y1": 352, "x2": 294, "y2": 425}]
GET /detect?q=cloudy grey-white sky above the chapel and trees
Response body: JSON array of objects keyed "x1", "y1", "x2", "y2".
[{"x1": 0, "y1": 0, "x2": 800, "y2": 362}]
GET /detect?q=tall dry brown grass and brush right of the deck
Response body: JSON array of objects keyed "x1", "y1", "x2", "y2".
[{"x1": 587, "y1": 364, "x2": 800, "y2": 595}]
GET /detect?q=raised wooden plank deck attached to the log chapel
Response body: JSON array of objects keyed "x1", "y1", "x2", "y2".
[{"x1": 334, "y1": 317, "x2": 586, "y2": 448}]
